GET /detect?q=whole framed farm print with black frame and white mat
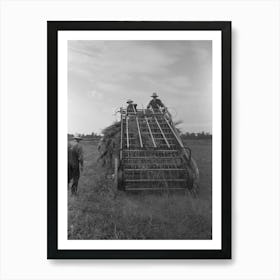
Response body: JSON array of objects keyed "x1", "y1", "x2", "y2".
[{"x1": 47, "y1": 21, "x2": 231, "y2": 259}]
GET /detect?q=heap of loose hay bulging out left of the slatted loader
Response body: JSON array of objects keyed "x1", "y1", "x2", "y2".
[{"x1": 98, "y1": 121, "x2": 121, "y2": 170}]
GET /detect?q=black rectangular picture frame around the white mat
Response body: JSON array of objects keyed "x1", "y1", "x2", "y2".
[{"x1": 47, "y1": 21, "x2": 231, "y2": 259}]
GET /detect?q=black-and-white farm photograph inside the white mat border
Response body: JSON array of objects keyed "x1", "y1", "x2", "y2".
[{"x1": 68, "y1": 41, "x2": 212, "y2": 239}]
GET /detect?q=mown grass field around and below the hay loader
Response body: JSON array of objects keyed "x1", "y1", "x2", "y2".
[{"x1": 68, "y1": 140, "x2": 212, "y2": 239}]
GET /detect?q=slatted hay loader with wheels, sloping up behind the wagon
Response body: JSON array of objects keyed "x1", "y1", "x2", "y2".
[{"x1": 115, "y1": 106, "x2": 199, "y2": 192}]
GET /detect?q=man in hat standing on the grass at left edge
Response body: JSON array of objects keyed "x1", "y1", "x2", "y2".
[{"x1": 68, "y1": 134, "x2": 84, "y2": 195}]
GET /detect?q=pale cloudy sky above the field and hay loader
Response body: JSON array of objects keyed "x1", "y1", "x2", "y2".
[{"x1": 68, "y1": 41, "x2": 212, "y2": 133}]
